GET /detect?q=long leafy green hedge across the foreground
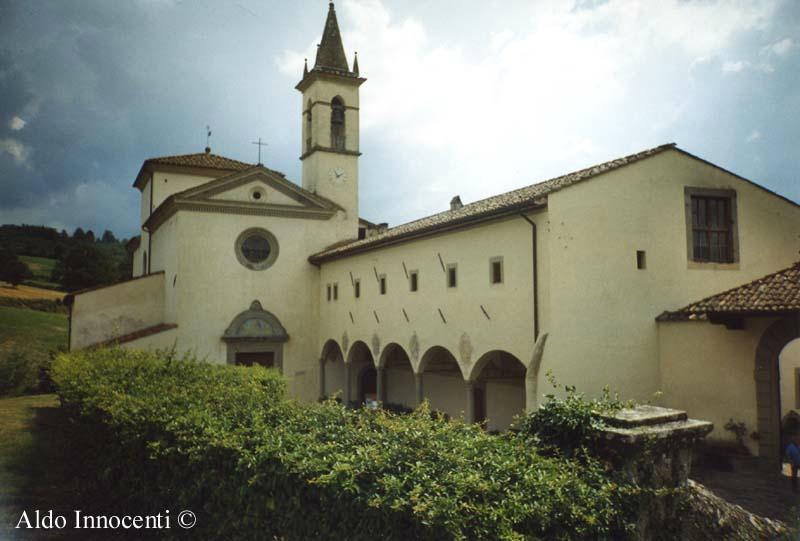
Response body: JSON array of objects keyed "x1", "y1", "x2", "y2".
[{"x1": 52, "y1": 349, "x2": 630, "y2": 540}]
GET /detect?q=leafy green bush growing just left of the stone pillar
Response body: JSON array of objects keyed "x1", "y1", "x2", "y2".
[{"x1": 520, "y1": 373, "x2": 632, "y2": 457}]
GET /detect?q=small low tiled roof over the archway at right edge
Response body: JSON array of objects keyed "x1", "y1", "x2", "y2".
[{"x1": 656, "y1": 261, "x2": 800, "y2": 321}]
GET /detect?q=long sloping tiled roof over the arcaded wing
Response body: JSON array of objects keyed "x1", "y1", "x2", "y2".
[{"x1": 309, "y1": 143, "x2": 675, "y2": 264}]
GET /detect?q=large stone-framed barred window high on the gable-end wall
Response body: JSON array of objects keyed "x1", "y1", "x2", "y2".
[{"x1": 686, "y1": 188, "x2": 738, "y2": 263}]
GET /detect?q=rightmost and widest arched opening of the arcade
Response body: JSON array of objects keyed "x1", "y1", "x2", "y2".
[{"x1": 469, "y1": 350, "x2": 525, "y2": 430}]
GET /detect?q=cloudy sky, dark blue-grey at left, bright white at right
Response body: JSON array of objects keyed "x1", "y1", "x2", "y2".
[{"x1": 0, "y1": 0, "x2": 800, "y2": 236}]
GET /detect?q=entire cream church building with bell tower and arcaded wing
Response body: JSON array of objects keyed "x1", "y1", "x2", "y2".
[{"x1": 67, "y1": 3, "x2": 800, "y2": 459}]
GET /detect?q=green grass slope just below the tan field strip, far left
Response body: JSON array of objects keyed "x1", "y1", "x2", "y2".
[{"x1": 0, "y1": 306, "x2": 67, "y2": 353}]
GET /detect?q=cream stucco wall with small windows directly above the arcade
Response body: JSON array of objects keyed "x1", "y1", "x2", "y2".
[{"x1": 317, "y1": 213, "x2": 546, "y2": 380}]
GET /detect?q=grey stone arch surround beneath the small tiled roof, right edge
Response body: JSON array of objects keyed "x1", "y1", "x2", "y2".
[{"x1": 755, "y1": 317, "x2": 800, "y2": 465}]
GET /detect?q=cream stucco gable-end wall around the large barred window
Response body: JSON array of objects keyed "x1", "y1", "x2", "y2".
[{"x1": 539, "y1": 151, "x2": 800, "y2": 402}]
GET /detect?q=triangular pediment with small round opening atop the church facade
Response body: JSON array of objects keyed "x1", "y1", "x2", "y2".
[{"x1": 176, "y1": 166, "x2": 337, "y2": 210}]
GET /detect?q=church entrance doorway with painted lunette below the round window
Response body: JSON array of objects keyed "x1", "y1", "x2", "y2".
[{"x1": 222, "y1": 301, "x2": 289, "y2": 372}]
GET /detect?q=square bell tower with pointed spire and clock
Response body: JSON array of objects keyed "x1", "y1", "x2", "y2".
[{"x1": 295, "y1": 2, "x2": 366, "y2": 237}]
